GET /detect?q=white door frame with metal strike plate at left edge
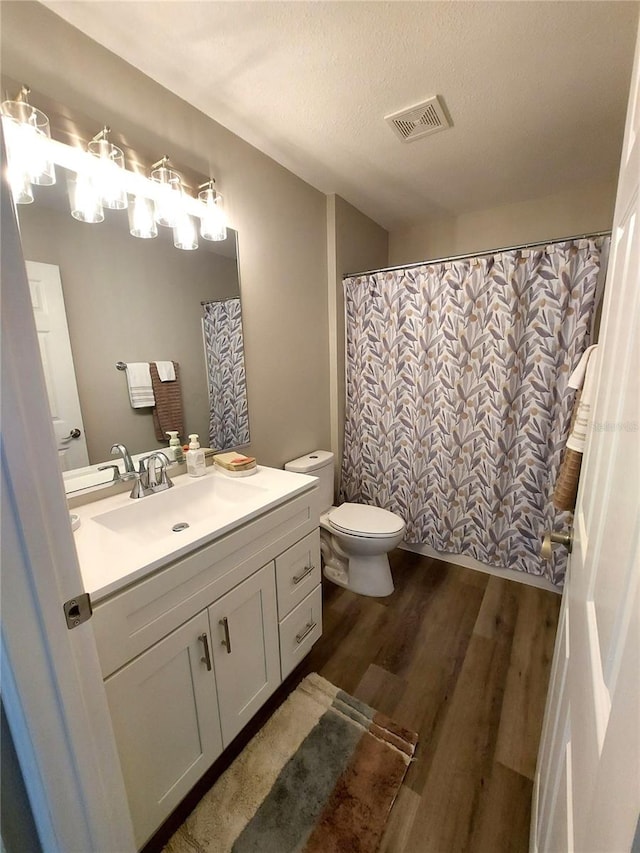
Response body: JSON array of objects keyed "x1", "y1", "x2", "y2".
[{"x1": 0, "y1": 138, "x2": 135, "y2": 853}]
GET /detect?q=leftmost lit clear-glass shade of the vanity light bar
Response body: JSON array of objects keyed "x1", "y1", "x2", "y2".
[{"x1": 0, "y1": 86, "x2": 56, "y2": 204}]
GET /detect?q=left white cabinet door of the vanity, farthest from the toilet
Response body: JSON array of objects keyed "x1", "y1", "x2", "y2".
[{"x1": 105, "y1": 611, "x2": 222, "y2": 846}]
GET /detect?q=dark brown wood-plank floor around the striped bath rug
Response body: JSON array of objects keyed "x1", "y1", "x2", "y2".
[{"x1": 145, "y1": 550, "x2": 560, "y2": 853}]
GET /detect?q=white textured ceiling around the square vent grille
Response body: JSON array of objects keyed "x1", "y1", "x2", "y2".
[{"x1": 44, "y1": 0, "x2": 638, "y2": 228}]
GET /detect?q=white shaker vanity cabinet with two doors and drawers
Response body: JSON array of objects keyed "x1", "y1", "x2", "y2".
[{"x1": 93, "y1": 488, "x2": 322, "y2": 847}]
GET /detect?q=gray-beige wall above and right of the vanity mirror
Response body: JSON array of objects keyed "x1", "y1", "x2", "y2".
[{"x1": 5, "y1": 2, "x2": 330, "y2": 466}]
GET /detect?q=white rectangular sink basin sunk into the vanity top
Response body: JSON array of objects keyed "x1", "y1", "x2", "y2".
[{"x1": 93, "y1": 474, "x2": 268, "y2": 544}]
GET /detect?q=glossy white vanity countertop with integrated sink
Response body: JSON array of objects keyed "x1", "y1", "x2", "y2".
[{"x1": 73, "y1": 466, "x2": 318, "y2": 602}]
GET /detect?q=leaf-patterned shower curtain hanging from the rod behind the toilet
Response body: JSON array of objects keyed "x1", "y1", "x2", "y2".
[{"x1": 341, "y1": 238, "x2": 608, "y2": 584}]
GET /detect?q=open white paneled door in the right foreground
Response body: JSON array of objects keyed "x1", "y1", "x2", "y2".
[{"x1": 532, "y1": 21, "x2": 640, "y2": 853}]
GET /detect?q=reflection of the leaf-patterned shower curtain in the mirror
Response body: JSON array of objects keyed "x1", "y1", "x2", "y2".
[{"x1": 202, "y1": 297, "x2": 249, "y2": 450}]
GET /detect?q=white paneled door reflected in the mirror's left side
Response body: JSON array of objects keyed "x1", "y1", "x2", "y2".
[{"x1": 26, "y1": 261, "x2": 89, "y2": 471}]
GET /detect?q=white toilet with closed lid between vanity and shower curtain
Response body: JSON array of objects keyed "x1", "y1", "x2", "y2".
[{"x1": 284, "y1": 450, "x2": 405, "y2": 596}]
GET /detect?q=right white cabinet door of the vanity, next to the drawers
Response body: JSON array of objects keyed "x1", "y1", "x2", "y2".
[{"x1": 209, "y1": 563, "x2": 280, "y2": 746}]
